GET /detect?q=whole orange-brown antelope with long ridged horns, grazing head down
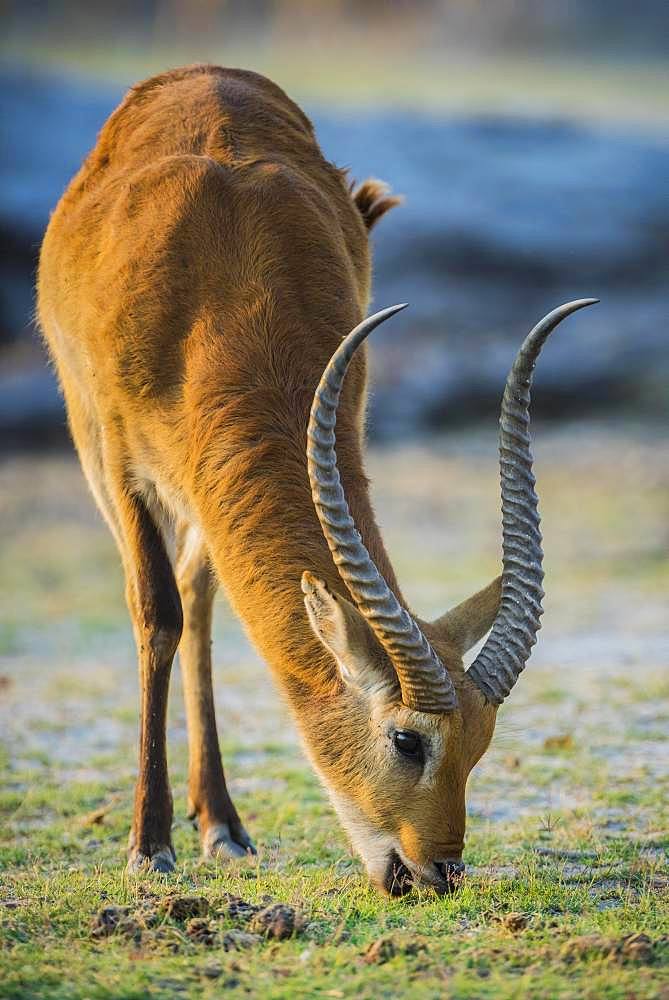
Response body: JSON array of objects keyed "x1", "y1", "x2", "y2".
[{"x1": 38, "y1": 65, "x2": 595, "y2": 895}]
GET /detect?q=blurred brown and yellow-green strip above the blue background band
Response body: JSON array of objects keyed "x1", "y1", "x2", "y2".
[{"x1": 5, "y1": 0, "x2": 667, "y2": 122}]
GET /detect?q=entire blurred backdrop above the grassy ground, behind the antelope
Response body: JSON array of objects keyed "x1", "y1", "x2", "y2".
[{"x1": 0, "y1": 0, "x2": 669, "y2": 447}]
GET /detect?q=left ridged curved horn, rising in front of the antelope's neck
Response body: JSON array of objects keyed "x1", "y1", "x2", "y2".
[{"x1": 307, "y1": 304, "x2": 457, "y2": 713}]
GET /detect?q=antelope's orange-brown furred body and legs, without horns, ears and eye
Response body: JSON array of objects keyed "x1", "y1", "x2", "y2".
[{"x1": 38, "y1": 66, "x2": 499, "y2": 881}]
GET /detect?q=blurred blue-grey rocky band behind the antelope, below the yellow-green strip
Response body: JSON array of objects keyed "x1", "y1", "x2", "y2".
[{"x1": 0, "y1": 70, "x2": 669, "y2": 440}]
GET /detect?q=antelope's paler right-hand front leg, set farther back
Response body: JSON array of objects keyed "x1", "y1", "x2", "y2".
[{"x1": 177, "y1": 528, "x2": 255, "y2": 858}]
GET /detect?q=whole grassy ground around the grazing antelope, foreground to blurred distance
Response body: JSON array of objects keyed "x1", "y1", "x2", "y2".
[{"x1": 0, "y1": 425, "x2": 669, "y2": 998}]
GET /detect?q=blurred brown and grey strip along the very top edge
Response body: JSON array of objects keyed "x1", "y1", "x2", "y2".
[{"x1": 4, "y1": 0, "x2": 667, "y2": 56}]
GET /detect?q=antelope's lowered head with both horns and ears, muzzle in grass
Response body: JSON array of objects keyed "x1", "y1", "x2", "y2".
[{"x1": 302, "y1": 299, "x2": 597, "y2": 895}]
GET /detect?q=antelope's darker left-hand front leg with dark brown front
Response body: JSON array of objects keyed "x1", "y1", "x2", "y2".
[{"x1": 119, "y1": 493, "x2": 182, "y2": 872}]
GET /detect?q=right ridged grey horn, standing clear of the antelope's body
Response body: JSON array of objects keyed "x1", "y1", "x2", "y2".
[{"x1": 467, "y1": 299, "x2": 599, "y2": 705}]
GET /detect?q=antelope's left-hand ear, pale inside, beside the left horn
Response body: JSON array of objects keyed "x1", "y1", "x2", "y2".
[{"x1": 302, "y1": 573, "x2": 389, "y2": 694}]
